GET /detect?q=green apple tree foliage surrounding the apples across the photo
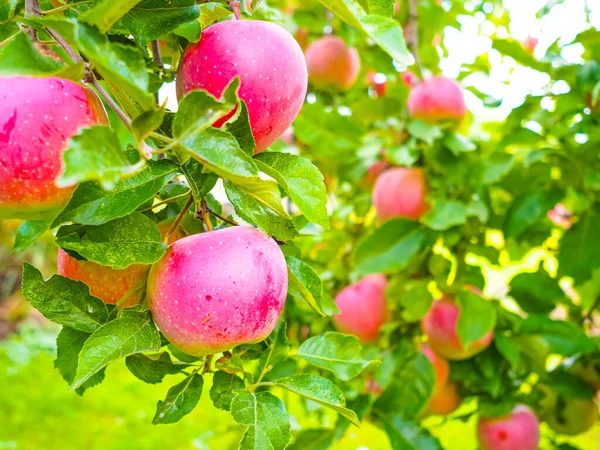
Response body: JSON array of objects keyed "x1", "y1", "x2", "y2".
[{"x1": 0, "y1": 0, "x2": 600, "y2": 450}]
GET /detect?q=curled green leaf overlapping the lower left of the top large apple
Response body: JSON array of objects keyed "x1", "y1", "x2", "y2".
[{"x1": 173, "y1": 77, "x2": 240, "y2": 141}]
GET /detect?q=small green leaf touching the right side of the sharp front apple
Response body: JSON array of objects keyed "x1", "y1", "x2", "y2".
[{"x1": 285, "y1": 256, "x2": 325, "y2": 316}]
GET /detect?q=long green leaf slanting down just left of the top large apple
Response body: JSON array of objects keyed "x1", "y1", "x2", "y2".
[{"x1": 75, "y1": 23, "x2": 154, "y2": 111}]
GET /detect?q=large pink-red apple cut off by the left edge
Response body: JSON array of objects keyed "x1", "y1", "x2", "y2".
[{"x1": 0, "y1": 76, "x2": 108, "y2": 219}]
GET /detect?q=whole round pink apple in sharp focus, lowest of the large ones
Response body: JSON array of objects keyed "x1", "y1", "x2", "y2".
[{"x1": 147, "y1": 226, "x2": 288, "y2": 356}]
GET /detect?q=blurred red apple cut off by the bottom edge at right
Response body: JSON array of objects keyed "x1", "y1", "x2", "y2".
[{"x1": 477, "y1": 405, "x2": 540, "y2": 450}]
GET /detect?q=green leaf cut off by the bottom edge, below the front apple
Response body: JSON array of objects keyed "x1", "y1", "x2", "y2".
[{"x1": 231, "y1": 390, "x2": 291, "y2": 450}]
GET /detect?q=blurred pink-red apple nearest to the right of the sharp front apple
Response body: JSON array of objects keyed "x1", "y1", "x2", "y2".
[{"x1": 333, "y1": 274, "x2": 388, "y2": 342}]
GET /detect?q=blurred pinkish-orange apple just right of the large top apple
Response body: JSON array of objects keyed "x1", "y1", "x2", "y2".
[{"x1": 306, "y1": 36, "x2": 360, "y2": 91}]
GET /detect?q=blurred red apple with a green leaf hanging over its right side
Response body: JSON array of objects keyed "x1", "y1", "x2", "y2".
[{"x1": 421, "y1": 296, "x2": 494, "y2": 360}]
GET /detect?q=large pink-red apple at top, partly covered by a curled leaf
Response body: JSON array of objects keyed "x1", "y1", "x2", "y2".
[{"x1": 177, "y1": 20, "x2": 308, "y2": 153}]
